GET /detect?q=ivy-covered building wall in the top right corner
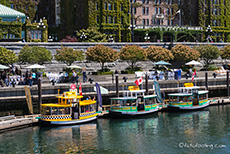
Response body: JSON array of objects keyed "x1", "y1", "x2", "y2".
[{"x1": 199, "y1": 0, "x2": 230, "y2": 42}]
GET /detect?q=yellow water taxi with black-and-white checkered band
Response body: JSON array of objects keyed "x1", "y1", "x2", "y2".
[{"x1": 40, "y1": 91, "x2": 98, "y2": 125}]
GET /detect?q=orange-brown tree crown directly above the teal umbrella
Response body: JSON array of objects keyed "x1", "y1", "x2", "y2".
[{"x1": 146, "y1": 46, "x2": 174, "y2": 61}]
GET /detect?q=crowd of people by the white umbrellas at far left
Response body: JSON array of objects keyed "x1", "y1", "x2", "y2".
[{"x1": 0, "y1": 66, "x2": 42, "y2": 87}]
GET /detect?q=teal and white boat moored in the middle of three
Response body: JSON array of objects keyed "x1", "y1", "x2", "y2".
[{"x1": 109, "y1": 90, "x2": 159, "y2": 118}]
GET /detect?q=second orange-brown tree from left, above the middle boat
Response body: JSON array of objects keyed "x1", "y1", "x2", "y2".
[{"x1": 119, "y1": 45, "x2": 147, "y2": 68}]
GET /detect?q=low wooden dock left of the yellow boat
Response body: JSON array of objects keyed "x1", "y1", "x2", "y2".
[{"x1": 0, "y1": 115, "x2": 39, "y2": 133}]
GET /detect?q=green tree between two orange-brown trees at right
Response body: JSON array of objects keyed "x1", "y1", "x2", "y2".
[{"x1": 194, "y1": 45, "x2": 220, "y2": 66}]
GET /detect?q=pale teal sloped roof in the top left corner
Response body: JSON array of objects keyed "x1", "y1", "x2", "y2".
[{"x1": 0, "y1": 4, "x2": 26, "y2": 17}]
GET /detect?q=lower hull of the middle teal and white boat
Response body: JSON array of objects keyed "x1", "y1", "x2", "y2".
[{"x1": 109, "y1": 108, "x2": 159, "y2": 118}]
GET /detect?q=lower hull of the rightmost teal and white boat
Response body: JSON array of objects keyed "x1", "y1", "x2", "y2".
[{"x1": 167, "y1": 101, "x2": 210, "y2": 111}]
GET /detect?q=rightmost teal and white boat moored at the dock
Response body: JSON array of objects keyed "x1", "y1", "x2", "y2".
[{"x1": 168, "y1": 86, "x2": 210, "y2": 111}]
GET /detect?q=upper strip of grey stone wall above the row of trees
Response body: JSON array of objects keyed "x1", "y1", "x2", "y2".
[{"x1": 0, "y1": 42, "x2": 229, "y2": 54}]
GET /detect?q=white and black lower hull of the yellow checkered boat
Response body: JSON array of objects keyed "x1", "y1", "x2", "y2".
[{"x1": 39, "y1": 116, "x2": 97, "y2": 126}]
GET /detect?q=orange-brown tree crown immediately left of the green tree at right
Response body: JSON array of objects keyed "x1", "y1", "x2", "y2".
[{"x1": 171, "y1": 44, "x2": 200, "y2": 61}]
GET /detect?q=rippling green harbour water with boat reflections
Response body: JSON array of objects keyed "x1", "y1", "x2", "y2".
[{"x1": 0, "y1": 105, "x2": 230, "y2": 154}]
